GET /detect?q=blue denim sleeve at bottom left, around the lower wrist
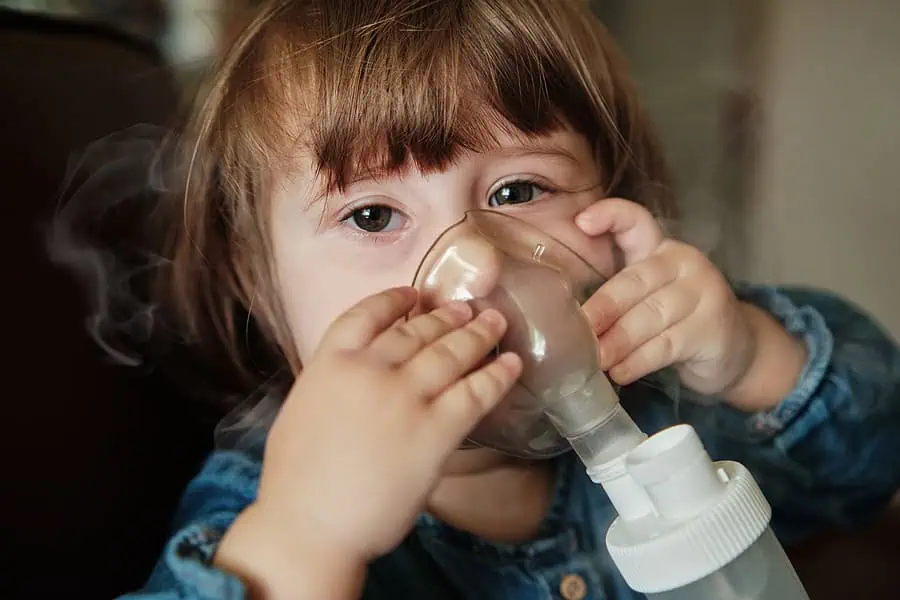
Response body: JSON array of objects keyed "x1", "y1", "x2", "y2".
[{"x1": 123, "y1": 451, "x2": 260, "y2": 600}]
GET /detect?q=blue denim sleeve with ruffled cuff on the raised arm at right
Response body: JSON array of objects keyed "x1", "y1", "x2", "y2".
[{"x1": 679, "y1": 286, "x2": 900, "y2": 543}]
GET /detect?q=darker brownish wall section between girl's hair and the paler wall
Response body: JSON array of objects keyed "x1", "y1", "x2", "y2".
[{"x1": 592, "y1": 0, "x2": 748, "y2": 254}]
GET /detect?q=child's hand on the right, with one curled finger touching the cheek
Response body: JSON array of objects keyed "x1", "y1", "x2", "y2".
[{"x1": 576, "y1": 199, "x2": 756, "y2": 394}]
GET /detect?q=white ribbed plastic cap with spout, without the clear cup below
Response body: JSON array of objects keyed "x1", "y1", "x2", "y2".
[{"x1": 606, "y1": 425, "x2": 772, "y2": 594}]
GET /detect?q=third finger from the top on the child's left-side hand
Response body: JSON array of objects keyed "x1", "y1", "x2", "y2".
[{"x1": 403, "y1": 309, "x2": 506, "y2": 399}]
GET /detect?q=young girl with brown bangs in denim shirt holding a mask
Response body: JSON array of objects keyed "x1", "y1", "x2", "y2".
[{"x1": 107, "y1": 0, "x2": 900, "y2": 600}]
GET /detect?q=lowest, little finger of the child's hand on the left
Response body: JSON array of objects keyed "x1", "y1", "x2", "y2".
[{"x1": 432, "y1": 352, "x2": 522, "y2": 448}]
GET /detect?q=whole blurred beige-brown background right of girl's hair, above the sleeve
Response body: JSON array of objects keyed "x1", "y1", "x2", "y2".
[{"x1": 592, "y1": 0, "x2": 900, "y2": 335}]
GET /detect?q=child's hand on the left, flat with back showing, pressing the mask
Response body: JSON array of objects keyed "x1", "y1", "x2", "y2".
[{"x1": 256, "y1": 288, "x2": 522, "y2": 561}]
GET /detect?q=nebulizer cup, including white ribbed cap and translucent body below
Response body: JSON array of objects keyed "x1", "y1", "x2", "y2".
[{"x1": 606, "y1": 424, "x2": 809, "y2": 600}]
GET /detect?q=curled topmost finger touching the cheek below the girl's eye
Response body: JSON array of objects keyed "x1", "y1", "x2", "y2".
[{"x1": 575, "y1": 198, "x2": 665, "y2": 266}]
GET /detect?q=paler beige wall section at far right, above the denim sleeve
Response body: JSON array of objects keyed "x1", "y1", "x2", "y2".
[{"x1": 748, "y1": 0, "x2": 900, "y2": 335}]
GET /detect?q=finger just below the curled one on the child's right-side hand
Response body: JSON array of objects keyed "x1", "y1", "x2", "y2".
[{"x1": 582, "y1": 254, "x2": 678, "y2": 335}]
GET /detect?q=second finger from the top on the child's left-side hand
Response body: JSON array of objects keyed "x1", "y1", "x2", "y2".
[{"x1": 369, "y1": 302, "x2": 472, "y2": 365}]
